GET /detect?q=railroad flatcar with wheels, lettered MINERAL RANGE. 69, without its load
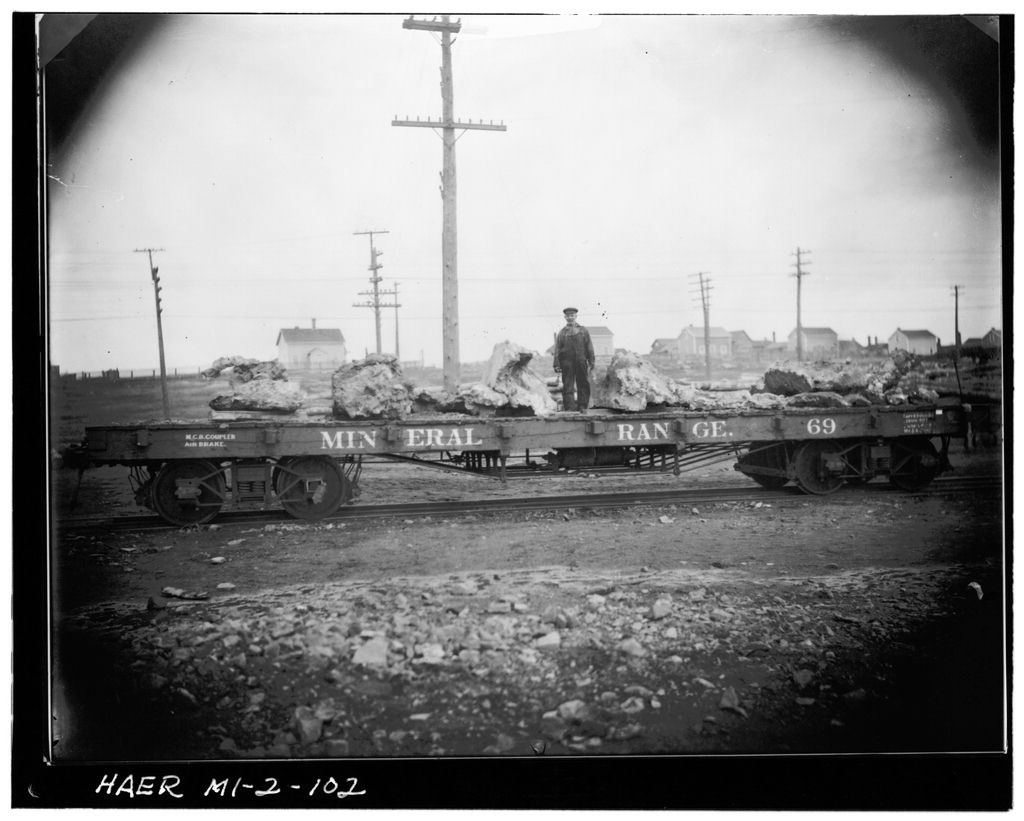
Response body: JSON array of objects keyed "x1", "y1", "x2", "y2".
[{"x1": 63, "y1": 400, "x2": 972, "y2": 525}]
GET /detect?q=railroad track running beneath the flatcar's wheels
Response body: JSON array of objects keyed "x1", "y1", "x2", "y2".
[{"x1": 58, "y1": 476, "x2": 1002, "y2": 532}]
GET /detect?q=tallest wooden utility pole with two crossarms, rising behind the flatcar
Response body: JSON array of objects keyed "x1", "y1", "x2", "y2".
[{"x1": 391, "y1": 14, "x2": 507, "y2": 392}]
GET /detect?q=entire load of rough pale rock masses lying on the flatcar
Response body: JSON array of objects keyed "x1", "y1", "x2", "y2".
[{"x1": 203, "y1": 340, "x2": 949, "y2": 420}]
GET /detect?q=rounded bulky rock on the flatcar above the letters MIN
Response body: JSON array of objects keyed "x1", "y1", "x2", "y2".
[{"x1": 331, "y1": 353, "x2": 413, "y2": 420}]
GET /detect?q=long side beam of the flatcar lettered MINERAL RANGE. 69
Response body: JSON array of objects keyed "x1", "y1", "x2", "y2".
[{"x1": 77, "y1": 405, "x2": 966, "y2": 465}]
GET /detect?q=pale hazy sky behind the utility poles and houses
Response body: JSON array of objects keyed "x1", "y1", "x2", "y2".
[{"x1": 46, "y1": 14, "x2": 1001, "y2": 372}]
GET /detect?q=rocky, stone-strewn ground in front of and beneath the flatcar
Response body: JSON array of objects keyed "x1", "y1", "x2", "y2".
[{"x1": 54, "y1": 442, "x2": 1005, "y2": 761}]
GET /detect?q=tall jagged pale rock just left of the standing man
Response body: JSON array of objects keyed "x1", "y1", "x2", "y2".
[{"x1": 459, "y1": 340, "x2": 558, "y2": 417}]
